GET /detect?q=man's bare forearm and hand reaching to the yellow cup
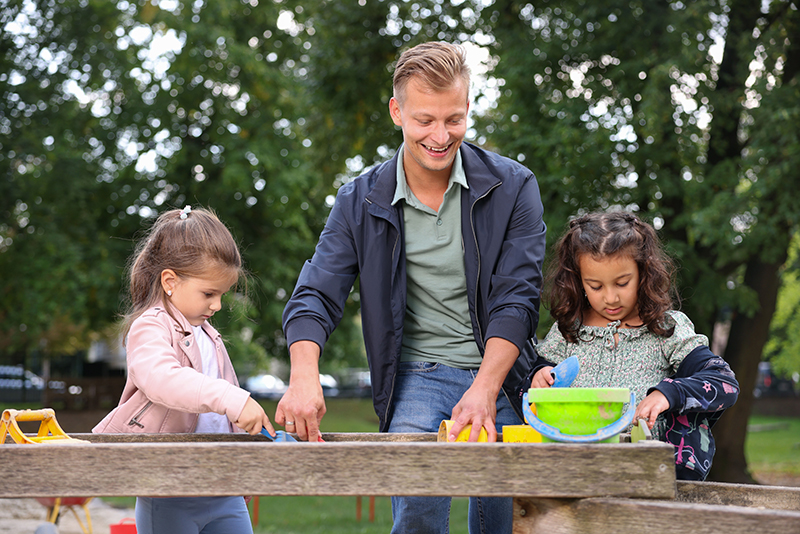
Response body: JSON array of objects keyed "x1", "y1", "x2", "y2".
[{"x1": 447, "y1": 337, "x2": 519, "y2": 442}]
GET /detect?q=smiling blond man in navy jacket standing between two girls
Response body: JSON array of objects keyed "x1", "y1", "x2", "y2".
[{"x1": 275, "y1": 42, "x2": 546, "y2": 533}]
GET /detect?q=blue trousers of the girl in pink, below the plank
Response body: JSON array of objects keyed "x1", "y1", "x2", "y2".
[{"x1": 136, "y1": 497, "x2": 253, "y2": 534}]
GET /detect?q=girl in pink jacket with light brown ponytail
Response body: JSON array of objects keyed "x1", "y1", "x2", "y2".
[{"x1": 92, "y1": 206, "x2": 274, "y2": 534}]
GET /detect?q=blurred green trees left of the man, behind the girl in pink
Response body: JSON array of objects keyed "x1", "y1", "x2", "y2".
[{"x1": 0, "y1": 0, "x2": 468, "y2": 374}]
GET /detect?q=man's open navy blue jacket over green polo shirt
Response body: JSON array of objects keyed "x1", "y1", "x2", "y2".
[{"x1": 283, "y1": 143, "x2": 546, "y2": 431}]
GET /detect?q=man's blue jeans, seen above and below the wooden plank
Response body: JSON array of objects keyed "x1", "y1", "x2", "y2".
[{"x1": 389, "y1": 362, "x2": 522, "y2": 534}]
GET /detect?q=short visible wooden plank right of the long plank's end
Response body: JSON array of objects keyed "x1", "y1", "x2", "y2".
[{"x1": 678, "y1": 481, "x2": 800, "y2": 512}]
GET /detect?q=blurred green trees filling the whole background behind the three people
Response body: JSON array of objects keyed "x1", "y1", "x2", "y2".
[{"x1": 0, "y1": 0, "x2": 800, "y2": 482}]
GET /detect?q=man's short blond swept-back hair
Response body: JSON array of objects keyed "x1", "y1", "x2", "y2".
[{"x1": 392, "y1": 41, "x2": 470, "y2": 103}]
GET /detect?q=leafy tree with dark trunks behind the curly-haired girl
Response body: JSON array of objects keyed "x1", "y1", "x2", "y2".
[{"x1": 480, "y1": 0, "x2": 800, "y2": 482}]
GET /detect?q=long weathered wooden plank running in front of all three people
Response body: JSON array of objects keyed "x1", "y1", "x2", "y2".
[{"x1": 0, "y1": 441, "x2": 675, "y2": 499}]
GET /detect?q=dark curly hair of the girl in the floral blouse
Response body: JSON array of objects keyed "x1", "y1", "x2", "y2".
[{"x1": 545, "y1": 212, "x2": 678, "y2": 343}]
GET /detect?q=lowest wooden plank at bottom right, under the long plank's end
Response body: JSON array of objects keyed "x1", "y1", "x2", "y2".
[{"x1": 513, "y1": 497, "x2": 800, "y2": 534}]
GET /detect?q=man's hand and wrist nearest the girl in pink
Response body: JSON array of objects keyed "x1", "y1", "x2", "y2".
[{"x1": 275, "y1": 341, "x2": 326, "y2": 442}]
